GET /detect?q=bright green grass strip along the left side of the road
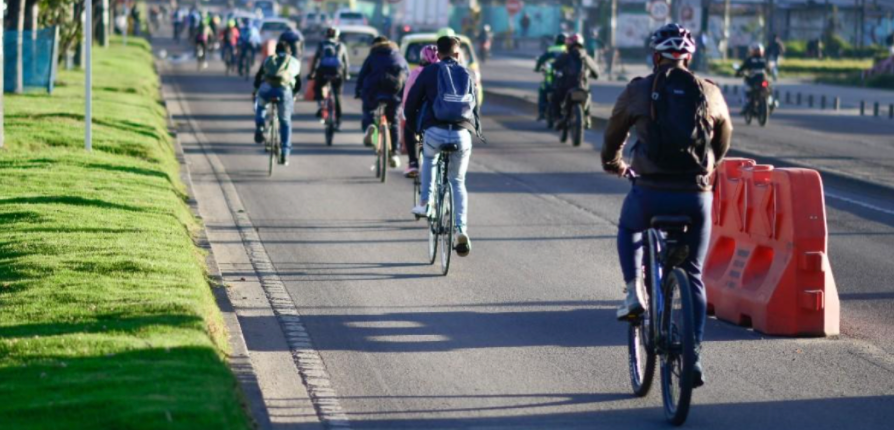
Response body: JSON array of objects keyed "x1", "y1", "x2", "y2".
[{"x1": 0, "y1": 38, "x2": 250, "y2": 429}]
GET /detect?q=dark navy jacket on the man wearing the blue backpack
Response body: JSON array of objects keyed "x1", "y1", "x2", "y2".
[{"x1": 404, "y1": 58, "x2": 482, "y2": 137}]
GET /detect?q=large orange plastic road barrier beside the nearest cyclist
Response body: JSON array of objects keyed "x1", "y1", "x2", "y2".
[{"x1": 704, "y1": 158, "x2": 840, "y2": 336}]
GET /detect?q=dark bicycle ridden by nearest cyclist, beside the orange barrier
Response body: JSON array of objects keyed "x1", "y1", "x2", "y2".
[{"x1": 627, "y1": 210, "x2": 696, "y2": 425}]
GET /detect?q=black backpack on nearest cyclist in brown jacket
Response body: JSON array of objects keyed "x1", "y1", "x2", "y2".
[{"x1": 645, "y1": 68, "x2": 713, "y2": 174}]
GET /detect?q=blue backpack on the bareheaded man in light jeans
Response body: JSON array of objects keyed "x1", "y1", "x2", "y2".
[{"x1": 432, "y1": 61, "x2": 475, "y2": 124}]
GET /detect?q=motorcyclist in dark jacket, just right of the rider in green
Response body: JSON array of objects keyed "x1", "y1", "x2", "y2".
[{"x1": 552, "y1": 34, "x2": 599, "y2": 129}]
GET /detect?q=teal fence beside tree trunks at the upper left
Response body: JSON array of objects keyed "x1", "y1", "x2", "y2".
[{"x1": 3, "y1": 27, "x2": 59, "y2": 93}]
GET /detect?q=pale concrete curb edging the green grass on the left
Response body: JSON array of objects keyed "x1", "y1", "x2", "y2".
[{"x1": 156, "y1": 92, "x2": 273, "y2": 429}]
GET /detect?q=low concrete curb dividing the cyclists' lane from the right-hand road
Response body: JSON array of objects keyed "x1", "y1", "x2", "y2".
[{"x1": 484, "y1": 89, "x2": 894, "y2": 196}]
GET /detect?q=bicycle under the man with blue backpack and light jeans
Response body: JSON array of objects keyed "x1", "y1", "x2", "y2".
[{"x1": 417, "y1": 143, "x2": 459, "y2": 276}]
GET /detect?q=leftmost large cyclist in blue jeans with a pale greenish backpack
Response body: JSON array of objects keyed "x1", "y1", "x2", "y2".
[{"x1": 252, "y1": 42, "x2": 301, "y2": 166}]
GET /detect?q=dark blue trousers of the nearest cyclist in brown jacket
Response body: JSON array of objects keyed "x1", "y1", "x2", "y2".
[{"x1": 618, "y1": 185, "x2": 714, "y2": 342}]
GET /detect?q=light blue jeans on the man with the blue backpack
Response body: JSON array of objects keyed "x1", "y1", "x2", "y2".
[{"x1": 420, "y1": 127, "x2": 472, "y2": 232}]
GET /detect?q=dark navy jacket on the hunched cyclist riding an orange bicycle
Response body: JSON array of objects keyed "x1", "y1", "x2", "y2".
[{"x1": 356, "y1": 42, "x2": 410, "y2": 105}]
